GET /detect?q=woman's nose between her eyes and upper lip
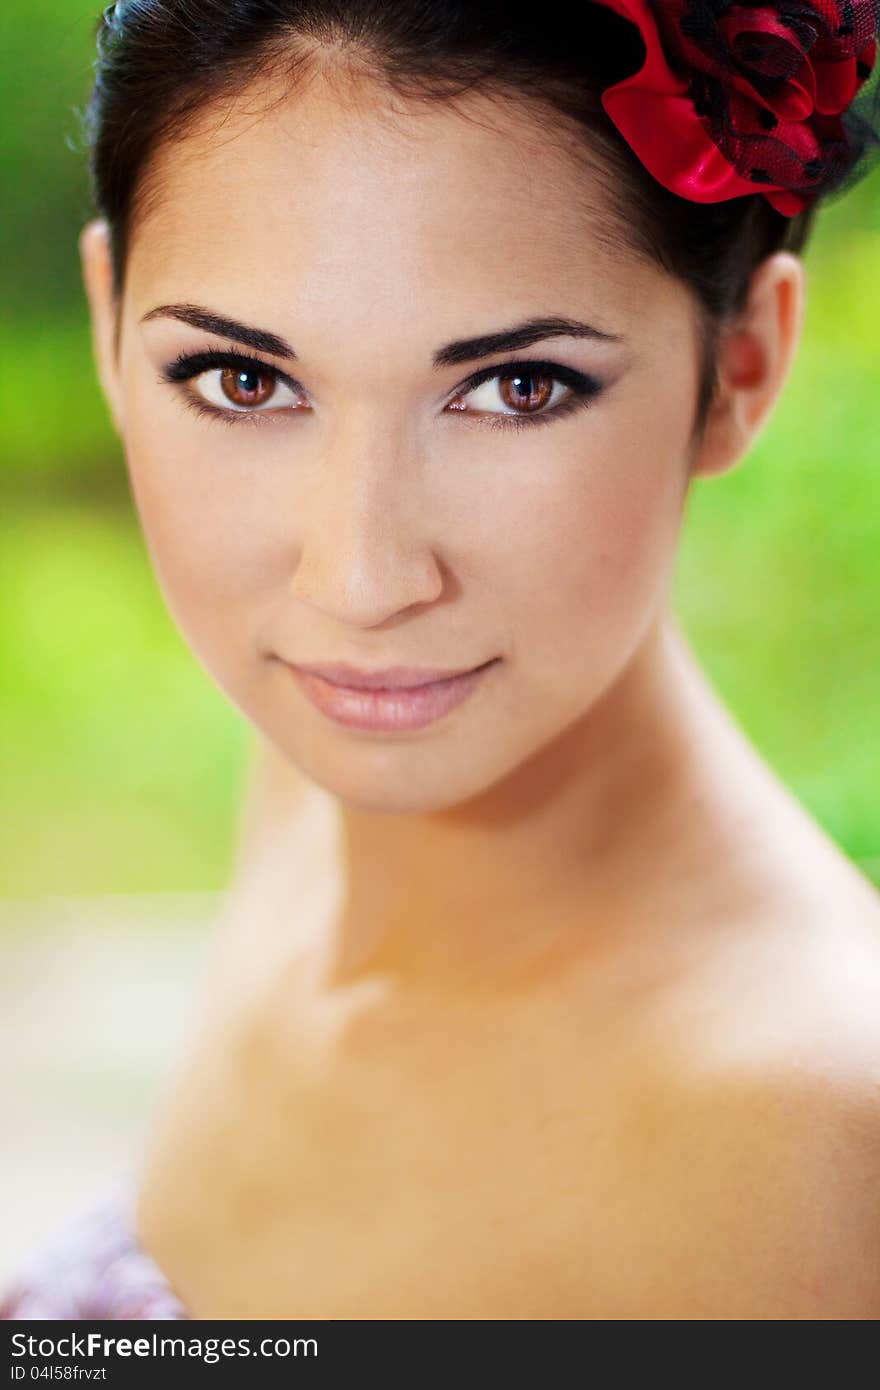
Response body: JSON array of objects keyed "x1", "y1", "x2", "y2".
[{"x1": 292, "y1": 417, "x2": 443, "y2": 627}]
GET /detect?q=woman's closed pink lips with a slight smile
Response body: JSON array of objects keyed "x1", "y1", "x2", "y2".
[{"x1": 285, "y1": 657, "x2": 499, "y2": 733}]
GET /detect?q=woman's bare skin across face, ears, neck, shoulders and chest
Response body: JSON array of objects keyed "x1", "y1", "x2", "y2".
[{"x1": 81, "y1": 54, "x2": 880, "y2": 1319}]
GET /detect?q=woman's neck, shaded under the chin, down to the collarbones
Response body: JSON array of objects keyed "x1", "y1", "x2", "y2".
[{"x1": 225, "y1": 614, "x2": 750, "y2": 990}]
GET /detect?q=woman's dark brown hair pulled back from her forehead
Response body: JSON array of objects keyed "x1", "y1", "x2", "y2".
[{"x1": 78, "y1": 0, "x2": 816, "y2": 436}]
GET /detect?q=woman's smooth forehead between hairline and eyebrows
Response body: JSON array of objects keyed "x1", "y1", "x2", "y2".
[{"x1": 127, "y1": 76, "x2": 683, "y2": 353}]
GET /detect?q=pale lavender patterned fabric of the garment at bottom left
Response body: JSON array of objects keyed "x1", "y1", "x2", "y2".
[{"x1": 0, "y1": 1180, "x2": 188, "y2": 1322}]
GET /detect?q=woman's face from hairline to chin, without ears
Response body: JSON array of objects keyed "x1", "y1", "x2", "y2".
[{"x1": 85, "y1": 73, "x2": 698, "y2": 810}]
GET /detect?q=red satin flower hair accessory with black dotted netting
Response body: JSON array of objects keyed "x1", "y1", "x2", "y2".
[{"x1": 599, "y1": 0, "x2": 880, "y2": 217}]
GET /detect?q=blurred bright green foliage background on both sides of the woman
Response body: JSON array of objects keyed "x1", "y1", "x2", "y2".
[{"x1": 0, "y1": 0, "x2": 880, "y2": 899}]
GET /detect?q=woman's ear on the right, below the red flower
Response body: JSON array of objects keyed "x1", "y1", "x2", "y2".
[{"x1": 691, "y1": 252, "x2": 806, "y2": 477}]
